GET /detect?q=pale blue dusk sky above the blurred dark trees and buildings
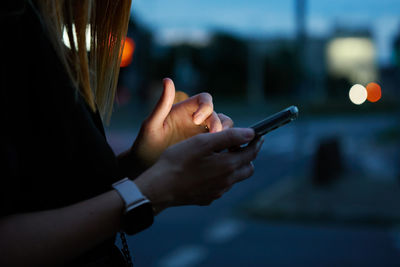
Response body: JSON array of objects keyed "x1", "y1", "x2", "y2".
[{"x1": 132, "y1": 0, "x2": 400, "y2": 64}]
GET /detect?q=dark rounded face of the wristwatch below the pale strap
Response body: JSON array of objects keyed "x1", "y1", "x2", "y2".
[{"x1": 122, "y1": 202, "x2": 154, "y2": 235}]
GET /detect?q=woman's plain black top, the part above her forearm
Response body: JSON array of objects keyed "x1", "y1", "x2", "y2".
[{"x1": 0, "y1": 0, "x2": 125, "y2": 266}]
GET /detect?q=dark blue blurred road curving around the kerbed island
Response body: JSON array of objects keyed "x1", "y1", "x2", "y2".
[{"x1": 108, "y1": 114, "x2": 400, "y2": 267}]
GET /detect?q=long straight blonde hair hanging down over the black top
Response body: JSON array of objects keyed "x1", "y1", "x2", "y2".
[{"x1": 36, "y1": 0, "x2": 131, "y2": 121}]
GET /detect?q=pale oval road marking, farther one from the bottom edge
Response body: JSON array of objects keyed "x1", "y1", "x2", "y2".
[{"x1": 204, "y1": 219, "x2": 244, "y2": 243}]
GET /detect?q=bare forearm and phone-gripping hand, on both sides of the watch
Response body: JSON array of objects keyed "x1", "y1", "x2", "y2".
[{"x1": 0, "y1": 128, "x2": 262, "y2": 266}]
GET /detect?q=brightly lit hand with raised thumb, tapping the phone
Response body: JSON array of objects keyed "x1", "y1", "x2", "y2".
[{"x1": 118, "y1": 78, "x2": 233, "y2": 178}]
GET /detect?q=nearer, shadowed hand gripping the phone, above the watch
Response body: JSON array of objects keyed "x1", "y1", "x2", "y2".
[{"x1": 135, "y1": 128, "x2": 263, "y2": 212}]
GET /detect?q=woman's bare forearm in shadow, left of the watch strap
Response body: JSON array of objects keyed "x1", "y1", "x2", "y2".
[{"x1": 0, "y1": 190, "x2": 124, "y2": 266}]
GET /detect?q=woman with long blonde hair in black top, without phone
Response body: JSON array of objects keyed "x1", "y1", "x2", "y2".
[{"x1": 0, "y1": 0, "x2": 262, "y2": 266}]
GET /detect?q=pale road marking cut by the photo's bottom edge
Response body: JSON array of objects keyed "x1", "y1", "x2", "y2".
[{"x1": 157, "y1": 245, "x2": 207, "y2": 267}]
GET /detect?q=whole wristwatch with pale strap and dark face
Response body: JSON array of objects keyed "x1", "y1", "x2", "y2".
[{"x1": 112, "y1": 178, "x2": 154, "y2": 235}]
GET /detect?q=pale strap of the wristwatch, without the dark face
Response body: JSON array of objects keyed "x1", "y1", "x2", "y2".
[{"x1": 112, "y1": 178, "x2": 150, "y2": 213}]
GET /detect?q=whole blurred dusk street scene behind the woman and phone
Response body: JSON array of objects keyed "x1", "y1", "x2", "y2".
[{"x1": 106, "y1": 0, "x2": 400, "y2": 267}]
